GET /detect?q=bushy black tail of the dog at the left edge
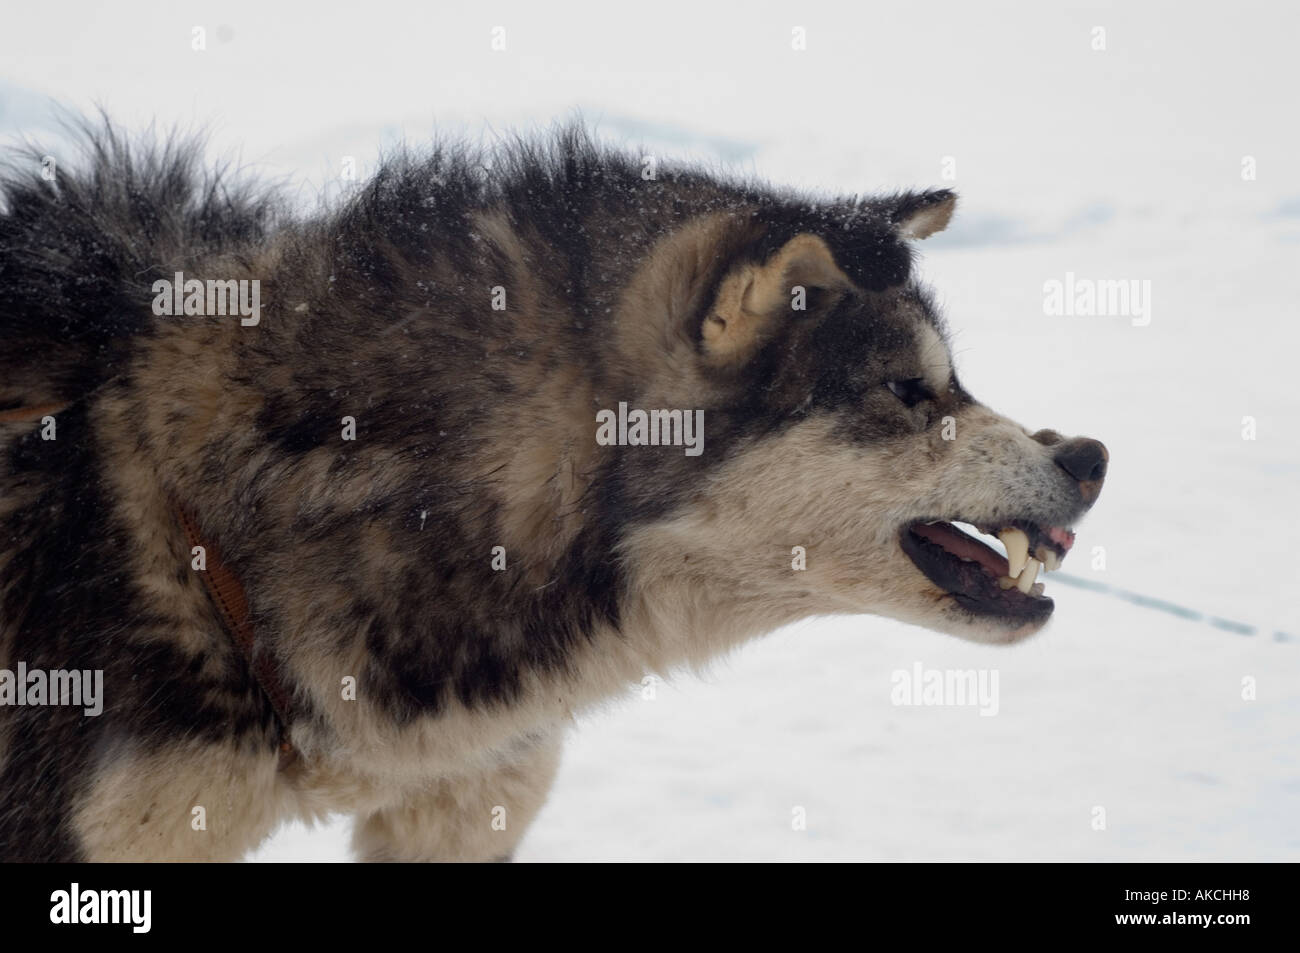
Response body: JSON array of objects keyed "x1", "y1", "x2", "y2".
[{"x1": 0, "y1": 121, "x2": 276, "y2": 413}]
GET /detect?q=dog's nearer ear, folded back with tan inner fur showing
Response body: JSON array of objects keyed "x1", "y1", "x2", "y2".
[{"x1": 701, "y1": 233, "x2": 853, "y2": 367}]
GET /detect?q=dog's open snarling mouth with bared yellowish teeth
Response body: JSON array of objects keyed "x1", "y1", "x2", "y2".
[{"x1": 898, "y1": 520, "x2": 1074, "y2": 624}]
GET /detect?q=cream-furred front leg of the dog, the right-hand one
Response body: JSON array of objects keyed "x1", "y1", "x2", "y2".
[{"x1": 352, "y1": 732, "x2": 562, "y2": 862}]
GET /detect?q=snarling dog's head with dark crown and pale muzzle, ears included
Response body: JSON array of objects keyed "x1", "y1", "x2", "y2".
[{"x1": 608, "y1": 185, "x2": 1108, "y2": 642}]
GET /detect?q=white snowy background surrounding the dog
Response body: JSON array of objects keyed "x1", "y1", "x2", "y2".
[{"x1": 0, "y1": 0, "x2": 1300, "y2": 861}]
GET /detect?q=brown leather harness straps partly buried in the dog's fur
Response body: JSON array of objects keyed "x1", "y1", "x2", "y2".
[{"x1": 0, "y1": 402, "x2": 298, "y2": 768}]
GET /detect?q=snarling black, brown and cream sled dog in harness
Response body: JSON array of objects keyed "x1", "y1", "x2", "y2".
[{"x1": 0, "y1": 127, "x2": 1106, "y2": 859}]
